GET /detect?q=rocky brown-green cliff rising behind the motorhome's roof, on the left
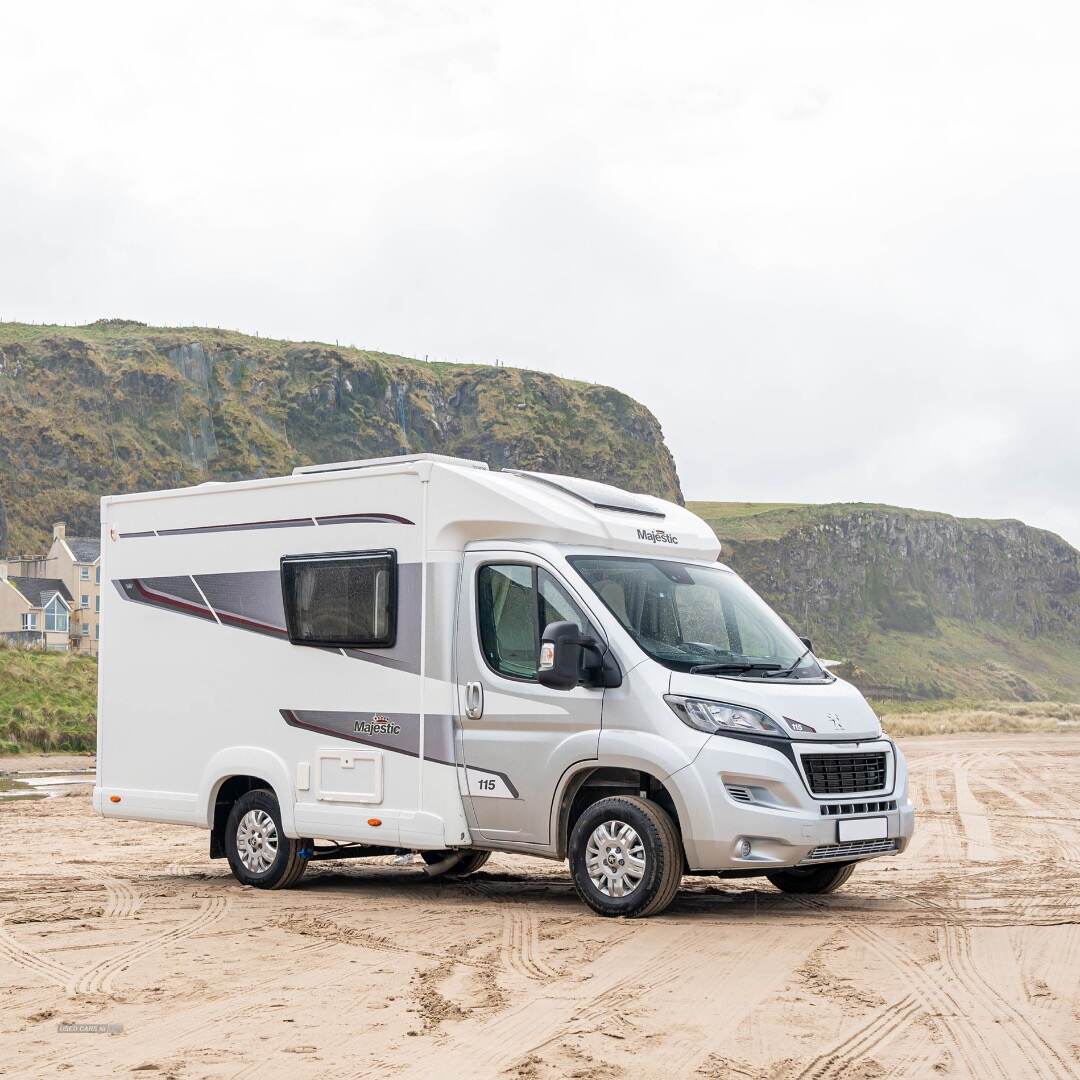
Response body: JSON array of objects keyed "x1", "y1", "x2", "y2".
[{"x1": 0, "y1": 321, "x2": 681, "y2": 551}]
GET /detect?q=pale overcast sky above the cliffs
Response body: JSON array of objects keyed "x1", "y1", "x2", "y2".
[{"x1": 0, "y1": 0, "x2": 1080, "y2": 544}]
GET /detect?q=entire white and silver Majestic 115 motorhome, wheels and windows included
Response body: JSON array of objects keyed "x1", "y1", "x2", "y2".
[{"x1": 94, "y1": 455, "x2": 914, "y2": 915}]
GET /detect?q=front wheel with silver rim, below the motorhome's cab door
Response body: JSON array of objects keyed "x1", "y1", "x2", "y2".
[{"x1": 569, "y1": 795, "x2": 685, "y2": 918}]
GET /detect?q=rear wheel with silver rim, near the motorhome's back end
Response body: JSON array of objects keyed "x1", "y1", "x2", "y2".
[{"x1": 225, "y1": 787, "x2": 311, "y2": 889}]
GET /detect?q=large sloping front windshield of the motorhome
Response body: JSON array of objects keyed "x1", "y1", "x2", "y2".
[{"x1": 569, "y1": 555, "x2": 825, "y2": 678}]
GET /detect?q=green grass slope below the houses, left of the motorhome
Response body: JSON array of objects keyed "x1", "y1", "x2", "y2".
[{"x1": 0, "y1": 647, "x2": 97, "y2": 754}]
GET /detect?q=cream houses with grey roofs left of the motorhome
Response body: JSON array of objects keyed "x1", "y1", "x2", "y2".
[{"x1": 0, "y1": 522, "x2": 102, "y2": 656}]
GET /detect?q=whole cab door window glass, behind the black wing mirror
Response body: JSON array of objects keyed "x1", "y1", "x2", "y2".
[{"x1": 476, "y1": 563, "x2": 598, "y2": 681}]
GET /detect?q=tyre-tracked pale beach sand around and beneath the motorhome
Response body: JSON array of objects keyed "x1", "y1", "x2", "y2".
[{"x1": 0, "y1": 734, "x2": 1080, "y2": 1080}]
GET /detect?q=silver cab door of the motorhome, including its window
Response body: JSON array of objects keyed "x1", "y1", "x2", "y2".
[{"x1": 456, "y1": 552, "x2": 604, "y2": 845}]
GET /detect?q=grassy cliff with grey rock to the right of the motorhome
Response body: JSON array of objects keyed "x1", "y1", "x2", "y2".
[{"x1": 689, "y1": 502, "x2": 1080, "y2": 701}]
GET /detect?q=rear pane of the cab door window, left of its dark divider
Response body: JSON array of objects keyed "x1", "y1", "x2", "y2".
[{"x1": 476, "y1": 564, "x2": 540, "y2": 679}]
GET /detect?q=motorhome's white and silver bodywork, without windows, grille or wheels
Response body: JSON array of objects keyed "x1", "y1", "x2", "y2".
[{"x1": 94, "y1": 457, "x2": 913, "y2": 869}]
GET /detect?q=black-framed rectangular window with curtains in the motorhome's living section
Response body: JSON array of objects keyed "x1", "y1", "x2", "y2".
[{"x1": 281, "y1": 551, "x2": 397, "y2": 649}]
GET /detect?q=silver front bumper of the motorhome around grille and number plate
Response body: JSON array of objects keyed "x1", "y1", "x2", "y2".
[{"x1": 667, "y1": 735, "x2": 915, "y2": 874}]
